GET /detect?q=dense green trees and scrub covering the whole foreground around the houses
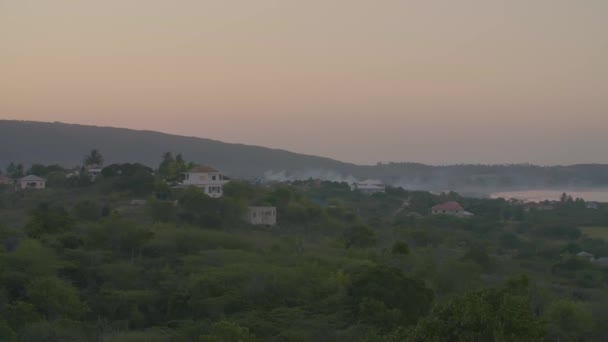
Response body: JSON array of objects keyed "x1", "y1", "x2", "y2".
[{"x1": 0, "y1": 156, "x2": 608, "y2": 342}]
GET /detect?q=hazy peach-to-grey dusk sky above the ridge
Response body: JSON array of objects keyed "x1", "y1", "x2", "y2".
[{"x1": 0, "y1": 0, "x2": 608, "y2": 165}]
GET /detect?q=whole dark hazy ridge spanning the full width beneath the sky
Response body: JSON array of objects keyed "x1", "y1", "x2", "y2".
[{"x1": 0, "y1": 120, "x2": 608, "y2": 192}]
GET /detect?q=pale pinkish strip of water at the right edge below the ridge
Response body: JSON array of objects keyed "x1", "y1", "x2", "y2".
[{"x1": 490, "y1": 189, "x2": 608, "y2": 202}]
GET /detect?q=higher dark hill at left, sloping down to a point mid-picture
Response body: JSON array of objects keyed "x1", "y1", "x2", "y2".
[{"x1": 0, "y1": 120, "x2": 354, "y2": 178}]
